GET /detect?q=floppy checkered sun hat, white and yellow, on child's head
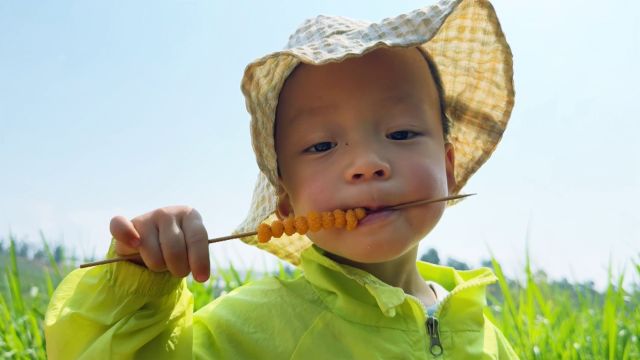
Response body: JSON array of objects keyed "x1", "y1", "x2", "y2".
[{"x1": 234, "y1": 0, "x2": 514, "y2": 265}]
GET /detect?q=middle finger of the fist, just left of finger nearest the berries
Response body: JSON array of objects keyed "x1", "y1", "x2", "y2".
[{"x1": 157, "y1": 215, "x2": 189, "y2": 277}]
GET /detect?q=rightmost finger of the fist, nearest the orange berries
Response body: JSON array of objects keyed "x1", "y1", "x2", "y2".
[{"x1": 182, "y1": 209, "x2": 210, "y2": 282}]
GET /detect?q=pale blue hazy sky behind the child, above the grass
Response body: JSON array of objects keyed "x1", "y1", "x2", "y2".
[{"x1": 0, "y1": 0, "x2": 640, "y2": 284}]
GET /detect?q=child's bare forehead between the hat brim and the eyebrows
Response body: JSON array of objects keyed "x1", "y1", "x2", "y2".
[{"x1": 277, "y1": 48, "x2": 438, "y2": 118}]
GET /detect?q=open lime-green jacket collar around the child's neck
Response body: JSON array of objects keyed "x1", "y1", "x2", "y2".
[{"x1": 302, "y1": 245, "x2": 497, "y2": 328}]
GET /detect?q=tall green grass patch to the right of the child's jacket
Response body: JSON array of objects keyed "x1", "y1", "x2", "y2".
[{"x1": 487, "y1": 253, "x2": 640, "y2": 359}]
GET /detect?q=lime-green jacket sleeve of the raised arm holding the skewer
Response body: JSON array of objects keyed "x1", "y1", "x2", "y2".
[{"x1": 44, "y1": 245, "x2": 193, "y2": 359}]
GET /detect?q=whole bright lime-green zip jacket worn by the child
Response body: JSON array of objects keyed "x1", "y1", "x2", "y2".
[{"x1": 45, "y1": 246, "x2": 517, "y2": 360}]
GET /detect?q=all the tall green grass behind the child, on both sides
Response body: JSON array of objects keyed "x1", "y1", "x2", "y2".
[{"x1": 0, "y1": 236, "x2": 640, "y2": 359}]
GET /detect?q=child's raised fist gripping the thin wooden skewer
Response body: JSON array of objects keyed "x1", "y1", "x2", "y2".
[{"x1": 110, "y1": 206, "x2": 209, "y2": 282}]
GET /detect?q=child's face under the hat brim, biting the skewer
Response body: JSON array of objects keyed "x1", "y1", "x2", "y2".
[{"x1": 276, "y1": 48, "x2": 455, "y2": 263}]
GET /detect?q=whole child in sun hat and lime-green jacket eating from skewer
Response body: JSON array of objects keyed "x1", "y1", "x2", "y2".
[{"x1": 45, "y1": 0, "x2": 517, "y2": 359}]
